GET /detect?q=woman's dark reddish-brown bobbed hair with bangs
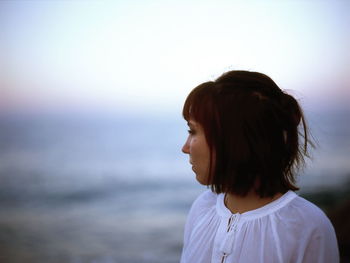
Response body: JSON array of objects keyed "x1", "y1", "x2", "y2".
[{"x1": 183, "y1": 71, "x2": 310, "y2": 197}]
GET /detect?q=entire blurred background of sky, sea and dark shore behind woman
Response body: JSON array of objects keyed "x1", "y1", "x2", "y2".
[{"x1": 0, "y1": 0, "x2": 350, "y2": 263}]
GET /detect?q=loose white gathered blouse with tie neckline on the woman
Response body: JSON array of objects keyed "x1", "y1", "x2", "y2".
[{"x1": 181, "y1": 190, "x2": 339, "y2": 263}]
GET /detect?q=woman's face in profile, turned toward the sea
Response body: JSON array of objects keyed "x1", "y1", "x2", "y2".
[{"x1": 182, "y1": 120, "x2": 210, "y2": 185}]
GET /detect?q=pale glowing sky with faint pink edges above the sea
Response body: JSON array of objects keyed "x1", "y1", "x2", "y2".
[{"x1": 0, "y1": 0, "x2": 350, "y2": 115}]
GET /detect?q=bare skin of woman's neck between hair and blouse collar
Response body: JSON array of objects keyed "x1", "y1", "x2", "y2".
[{"x1": 225, "y1": 191, "x2": 283, "y2": 214}]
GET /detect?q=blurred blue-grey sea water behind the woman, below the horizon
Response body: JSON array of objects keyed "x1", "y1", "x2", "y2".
[{"x1": 0, "y1": 112, "x2": 350, "y2": 263}]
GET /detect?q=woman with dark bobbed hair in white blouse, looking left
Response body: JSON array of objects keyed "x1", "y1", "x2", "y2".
[{"x1": 181, "y1": 71, "x2": 339, "y2": 263}]
